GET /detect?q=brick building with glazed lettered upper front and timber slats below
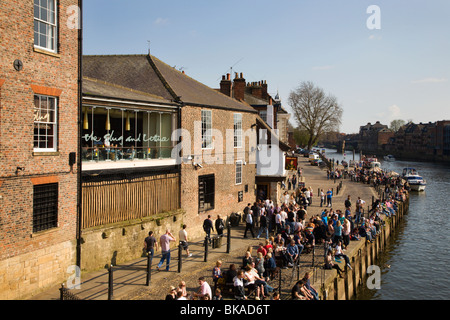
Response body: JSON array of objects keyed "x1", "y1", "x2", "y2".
[{"x1": 81, "y1": 55, "x2": 257, "y2": 270}]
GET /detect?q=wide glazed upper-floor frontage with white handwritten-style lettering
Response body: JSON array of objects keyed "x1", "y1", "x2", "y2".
[{"x1": 81, "y1": 106, "x2": 176, "y2": 161}]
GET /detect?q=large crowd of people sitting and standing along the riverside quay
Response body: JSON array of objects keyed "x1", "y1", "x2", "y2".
[{"x1": 153, "y1": 156, "x2": 408, "y2": 300}]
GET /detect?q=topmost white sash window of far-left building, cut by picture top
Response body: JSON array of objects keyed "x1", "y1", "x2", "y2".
[{"x1": 34, "y1": 0, "x2": 57, "y2": 52}]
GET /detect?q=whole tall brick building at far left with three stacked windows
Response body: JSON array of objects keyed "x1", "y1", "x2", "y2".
[{"x1": 0, "y1": 0, "x2": 80, "y2": 299}]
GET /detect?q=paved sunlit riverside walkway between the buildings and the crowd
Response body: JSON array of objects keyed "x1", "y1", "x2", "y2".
[{"x1": 30, "y1": 157, "x2": 384, "y2": 300}]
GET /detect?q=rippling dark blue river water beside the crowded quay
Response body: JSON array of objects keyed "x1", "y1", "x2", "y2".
[{"x1": 326, "y1": 149, "x2": 450, "y2": 300}]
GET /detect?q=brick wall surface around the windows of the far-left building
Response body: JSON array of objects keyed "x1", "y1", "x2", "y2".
[{"x1": 0, "y1": 0, "x2": 78, "y2": 299}]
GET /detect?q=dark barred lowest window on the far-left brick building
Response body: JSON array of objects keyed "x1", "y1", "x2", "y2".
[{"x1": 33, "y1": 183, "x2": 58, "y2": 232}]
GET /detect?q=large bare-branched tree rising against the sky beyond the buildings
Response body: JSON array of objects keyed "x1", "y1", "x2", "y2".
[{"x1": 289, "y1": 81, "x2": 343, "y2": 149}]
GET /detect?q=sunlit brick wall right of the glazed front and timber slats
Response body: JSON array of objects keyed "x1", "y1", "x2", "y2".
[{"x1": 181, "y1": 106, "x2": 256, "y2": 237}]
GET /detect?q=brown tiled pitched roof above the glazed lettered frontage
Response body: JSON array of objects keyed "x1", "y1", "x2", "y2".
[{"x1": 83, "y1": 55, "x2": 256, "y2": 113}]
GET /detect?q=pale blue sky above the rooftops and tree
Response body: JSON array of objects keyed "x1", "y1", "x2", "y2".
[{"x1": 83, "y1": 0, "x2": 450, "y2": 133}]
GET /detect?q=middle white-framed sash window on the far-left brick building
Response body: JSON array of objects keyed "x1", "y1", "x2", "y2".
[{"x1": 34, "y1": 95, "x2": 57, "y2": 152}]
